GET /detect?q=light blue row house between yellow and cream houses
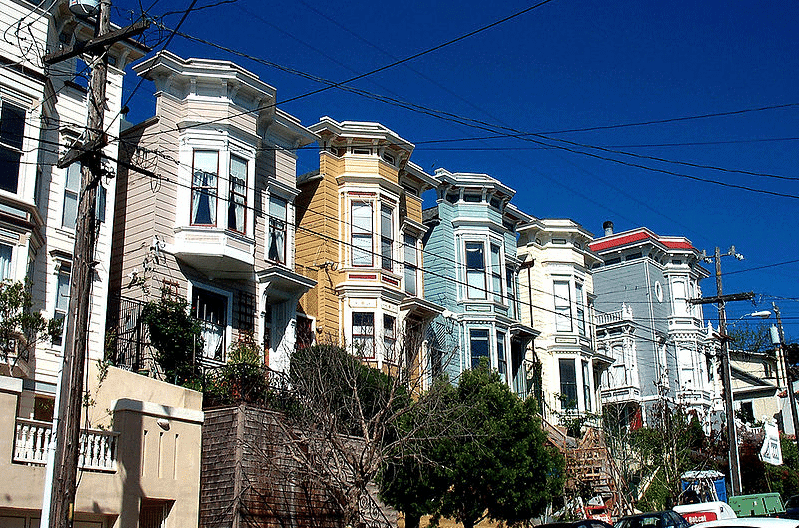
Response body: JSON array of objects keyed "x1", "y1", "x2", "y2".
[{"x1": 423, "y1": 169, "x2": 537, "y2": 395}]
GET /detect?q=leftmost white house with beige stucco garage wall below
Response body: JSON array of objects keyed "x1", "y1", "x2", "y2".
[{"x1": 0, "y1": 4, "x2": 202, "y2": 528}]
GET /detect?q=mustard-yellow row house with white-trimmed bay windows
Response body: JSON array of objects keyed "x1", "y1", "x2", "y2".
[{"x1": 296, "y1": 117, "x2": 442, "y2": 379}]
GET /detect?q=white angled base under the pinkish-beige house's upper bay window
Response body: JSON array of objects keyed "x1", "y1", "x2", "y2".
[{"x1": 172, "y1": 227, "x2": 255, "y2": 279}]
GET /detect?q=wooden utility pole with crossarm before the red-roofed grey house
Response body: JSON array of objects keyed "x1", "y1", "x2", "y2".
[{"x1": 688, "y1": 246, "x2": 755, "y2": 496}]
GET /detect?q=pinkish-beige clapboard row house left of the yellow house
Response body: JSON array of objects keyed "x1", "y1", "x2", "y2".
[{"x1": 110, "y1": 51, "x2": 317, "y2": 371}]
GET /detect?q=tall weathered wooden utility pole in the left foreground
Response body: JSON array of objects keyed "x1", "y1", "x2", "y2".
[{"x1": 42, "y1": 0, "x2": 148, "y2": 528}]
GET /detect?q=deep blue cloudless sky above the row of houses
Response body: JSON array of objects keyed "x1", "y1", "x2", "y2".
[{"x1": 112, "y1": 0, "x2": 799, "y2": 341}]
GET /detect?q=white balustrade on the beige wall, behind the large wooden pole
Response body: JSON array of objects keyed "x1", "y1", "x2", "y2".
[{"x1": 13, "y1": 418, "x2": 119, "y2": 473}]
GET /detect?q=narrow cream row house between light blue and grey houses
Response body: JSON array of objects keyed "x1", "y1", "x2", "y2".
[{"x1": 518, "y1": 219, "x2": 612, "y2": 422}]
